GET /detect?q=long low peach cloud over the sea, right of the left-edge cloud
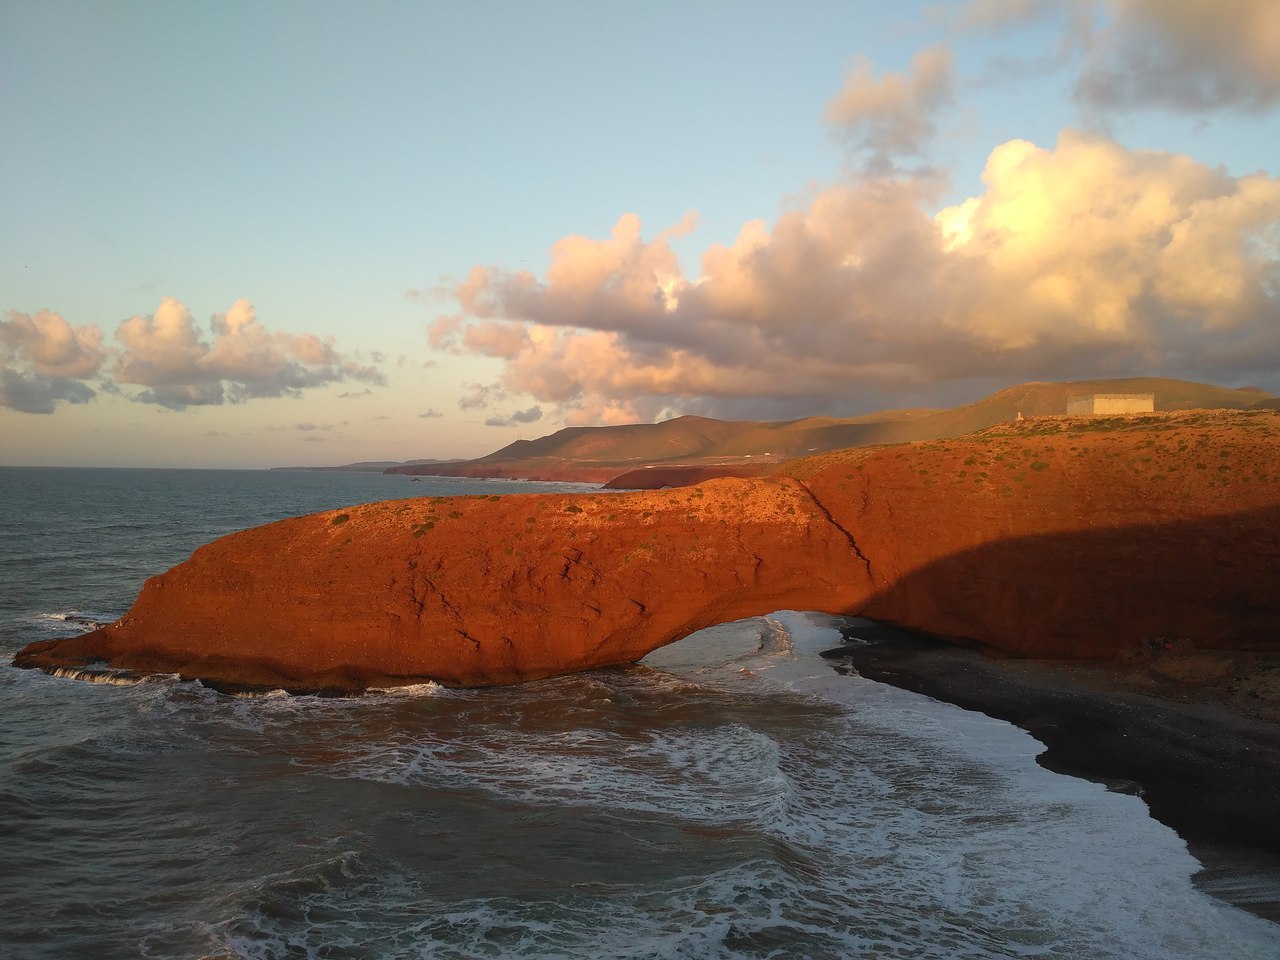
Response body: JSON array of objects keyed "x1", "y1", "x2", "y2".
[{"x1": 114, "y1": 297, "x2": 385, "y2": 410}]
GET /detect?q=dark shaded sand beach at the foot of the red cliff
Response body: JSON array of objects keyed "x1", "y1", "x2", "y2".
[{"x1": 824, "y1": 620, "x2": 1280, "y2": 922}]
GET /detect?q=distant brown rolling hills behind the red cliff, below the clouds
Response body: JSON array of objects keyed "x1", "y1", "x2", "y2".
[{"x1": 387, "y1": 376, "x2": 1280, "y2": 480}]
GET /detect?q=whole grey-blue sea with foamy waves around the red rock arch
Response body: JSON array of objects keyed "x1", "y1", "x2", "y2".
[{"x1": 0, "y1": 468, "x2": 1280, "y2": 960}]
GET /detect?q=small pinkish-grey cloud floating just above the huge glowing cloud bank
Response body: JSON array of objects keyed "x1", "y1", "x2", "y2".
[{"x1": 826, "y1": 44, "x2": 954, "y2": 173}]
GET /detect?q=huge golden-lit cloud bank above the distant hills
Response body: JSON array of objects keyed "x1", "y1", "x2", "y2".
[{"x1": 435, "y1": 131, "x2": 1280, "y2": 422}]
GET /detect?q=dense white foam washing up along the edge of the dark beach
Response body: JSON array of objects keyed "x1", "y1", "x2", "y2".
[{"x1": 759, "y1": 612, "x2": 1280, "y2": 960}]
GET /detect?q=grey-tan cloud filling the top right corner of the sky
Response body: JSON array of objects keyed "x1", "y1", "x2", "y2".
[{"x1": 1076, "y1": 0, "x2": 1280, "y2": 110}]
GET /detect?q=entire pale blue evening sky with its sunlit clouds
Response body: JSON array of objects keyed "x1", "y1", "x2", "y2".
[{"x1": 0, "y1": 0, "x2": 1280, "y2": 467}]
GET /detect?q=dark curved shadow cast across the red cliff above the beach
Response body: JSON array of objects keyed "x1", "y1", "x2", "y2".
[{"x1": 840, "y1": 506, "x2": 1280, "y2": 658}]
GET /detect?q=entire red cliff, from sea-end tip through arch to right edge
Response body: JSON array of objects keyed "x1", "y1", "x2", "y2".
[{"x1": 15, "y1": 412, "x2": 1280, "y2": 689}]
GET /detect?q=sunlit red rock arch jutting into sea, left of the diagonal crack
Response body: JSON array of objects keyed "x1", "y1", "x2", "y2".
[{"x1": 18, "y1": 479, "x2": 870, "y2": 689}]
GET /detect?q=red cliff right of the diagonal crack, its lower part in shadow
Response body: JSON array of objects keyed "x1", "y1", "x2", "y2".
[{"x1": 799, "y1": 412, "x2": 1280, "y2": 658}]
